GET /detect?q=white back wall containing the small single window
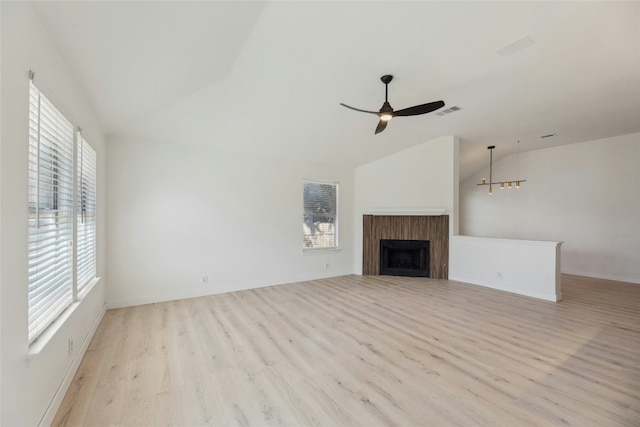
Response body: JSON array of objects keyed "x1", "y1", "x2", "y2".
[{"x1": 107, "y1": 135, "x2": 353, "y2": 307}]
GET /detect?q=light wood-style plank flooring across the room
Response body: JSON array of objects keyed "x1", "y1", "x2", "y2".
[{"x1": 54, "y1": 275, "x2": 640, "y2": 427}]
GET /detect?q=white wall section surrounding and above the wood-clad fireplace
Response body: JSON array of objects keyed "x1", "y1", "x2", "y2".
[{"x1": 354, "y1": 136, "x2": 459, "y2": 274}]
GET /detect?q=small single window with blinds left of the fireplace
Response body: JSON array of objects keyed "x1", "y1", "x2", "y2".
[{"x1": 302, "y1": 181, "x2": 338, "y2": 250}]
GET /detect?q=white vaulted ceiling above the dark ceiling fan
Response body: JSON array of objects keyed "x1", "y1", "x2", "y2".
[{"x1": 33, "y1": 1, "x2": 640, "y2": 178}]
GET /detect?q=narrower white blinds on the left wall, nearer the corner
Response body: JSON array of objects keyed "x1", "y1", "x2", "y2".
[{"x1": 76, "y1": 133, "x2": 97, "y2": 296}]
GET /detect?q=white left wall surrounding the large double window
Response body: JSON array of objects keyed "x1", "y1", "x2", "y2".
[{"x1": 0, "y1": 2, "x2": 105, "y2": 426}]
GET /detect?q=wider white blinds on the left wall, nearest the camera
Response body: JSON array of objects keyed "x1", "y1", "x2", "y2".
[{"x1": 28, "y1": 83, "x2": 74, "y2": 342}]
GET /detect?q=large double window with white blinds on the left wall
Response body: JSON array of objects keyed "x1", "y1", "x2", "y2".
[{"x1": 28, "y1": 81, "x2": 97, "y2": 343}]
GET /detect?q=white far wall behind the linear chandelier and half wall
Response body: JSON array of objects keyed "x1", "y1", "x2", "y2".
[{"x1": 460, "y1": 133, "x2": 640, "y2": 283}]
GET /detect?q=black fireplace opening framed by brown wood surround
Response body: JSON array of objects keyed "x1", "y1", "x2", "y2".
[{"x1": 380, "y1": 239, "x2": 429, "y2": 277}]
